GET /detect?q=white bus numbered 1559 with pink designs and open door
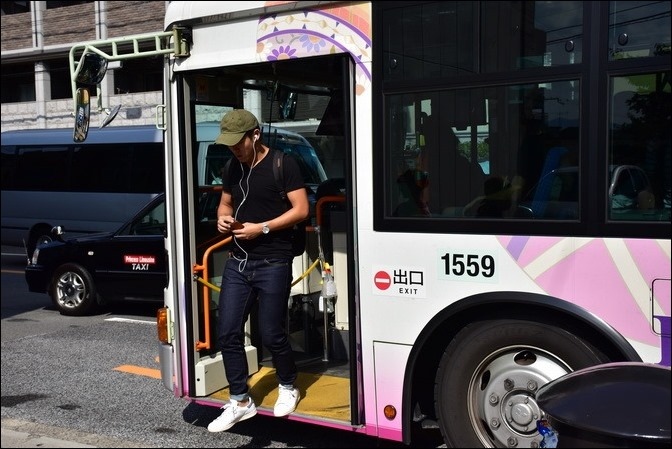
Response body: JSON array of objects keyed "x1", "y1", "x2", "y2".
[{"x1": 65, "y1": 1, "x2": 672, "y2": 447}]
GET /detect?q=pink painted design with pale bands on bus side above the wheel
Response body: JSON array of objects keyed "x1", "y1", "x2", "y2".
[{"x1": 499, "y1": 236, "x2": 670, "y2": 360}]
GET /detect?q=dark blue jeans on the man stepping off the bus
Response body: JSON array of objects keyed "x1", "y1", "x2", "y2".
[{"x1": 217, "y1": 257, "x2": 296, "y2": 401}]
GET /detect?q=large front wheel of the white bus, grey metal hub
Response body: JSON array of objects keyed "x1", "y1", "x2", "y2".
[{"x1": 434, "y1": 320, "x2": 608, "y2": 447}]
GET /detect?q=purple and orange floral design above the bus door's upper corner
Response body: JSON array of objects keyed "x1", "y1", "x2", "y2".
[{"x1": 257, "y1": 2, "x2": 371, "y2": 95}]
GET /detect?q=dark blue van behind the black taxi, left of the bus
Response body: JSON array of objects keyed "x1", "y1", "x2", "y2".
[{"x1": 1, "y1": 125, "x2": 165, "y2": 257}]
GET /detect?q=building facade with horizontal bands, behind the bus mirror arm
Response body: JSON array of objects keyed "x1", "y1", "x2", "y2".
[{"x1": 0, "y1": 1, "x2": 168, "y2": 131}]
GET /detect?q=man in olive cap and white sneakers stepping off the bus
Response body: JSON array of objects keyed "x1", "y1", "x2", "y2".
[{"x1": 208, "y1": 109, "x2": 309, "y2": 432}]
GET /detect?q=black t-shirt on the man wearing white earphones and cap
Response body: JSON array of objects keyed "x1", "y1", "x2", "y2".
[{"x1": 222, "y1": 150, "x2": 305, "y2": 259}]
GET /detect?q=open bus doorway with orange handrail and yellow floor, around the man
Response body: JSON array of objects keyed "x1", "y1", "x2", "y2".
[{"x1": 178, "y1": 55, "x2": 357, "y2": 425}]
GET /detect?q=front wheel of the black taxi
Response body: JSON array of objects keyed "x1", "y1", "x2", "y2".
[{"x1": 49, "y1": 263, "x2": 98, "y2": 316}]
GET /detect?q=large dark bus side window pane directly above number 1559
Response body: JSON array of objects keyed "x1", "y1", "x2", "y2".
[{"x1": 387, "y1": 81, "x2": 580, "y2": 220}]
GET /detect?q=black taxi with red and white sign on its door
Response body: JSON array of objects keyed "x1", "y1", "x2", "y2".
[{"x1": 25, "y1": 186, "x2": 222, "y2": 316}]
